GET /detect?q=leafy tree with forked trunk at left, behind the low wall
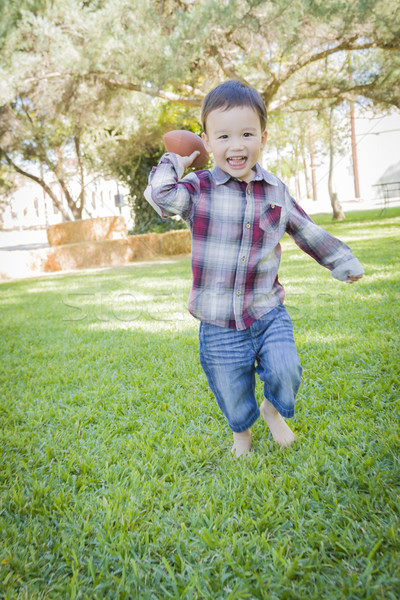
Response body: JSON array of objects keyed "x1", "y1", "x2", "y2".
[{"x1": 0, "y1": 54, "x2": 156, "y2": 221}]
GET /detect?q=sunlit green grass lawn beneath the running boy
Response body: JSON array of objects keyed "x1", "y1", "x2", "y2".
[{"x1": 0, "y1": 209, "x2": 400, "y2": 600}]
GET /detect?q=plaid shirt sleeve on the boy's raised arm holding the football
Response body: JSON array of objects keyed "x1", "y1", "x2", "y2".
[{"x1": 144, "y1": 152, "x2": 199, "y2": 221}]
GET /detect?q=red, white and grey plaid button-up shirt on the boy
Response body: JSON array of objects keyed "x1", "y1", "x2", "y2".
[{"x1": 145, "y1": 153, "x2": 363, "y2": 330}]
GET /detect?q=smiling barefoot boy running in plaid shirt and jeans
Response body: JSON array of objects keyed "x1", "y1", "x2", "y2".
[{"x1": 145, "y1": 80, "x2": 363, "y2": 456}]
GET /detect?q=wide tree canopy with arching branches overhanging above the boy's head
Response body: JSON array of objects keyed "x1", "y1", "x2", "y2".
[{"x1": 3, "y1": 0, "x2": 400, "y2": 110}]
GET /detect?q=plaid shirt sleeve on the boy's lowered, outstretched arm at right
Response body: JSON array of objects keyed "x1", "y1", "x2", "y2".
[{"x1": 286, "y1": 198, "x2": 364, "y2": 281}]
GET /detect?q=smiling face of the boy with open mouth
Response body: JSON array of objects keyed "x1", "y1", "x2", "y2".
[{"x1": 202, "y1": 106, "x2": 267, "y2": 182}]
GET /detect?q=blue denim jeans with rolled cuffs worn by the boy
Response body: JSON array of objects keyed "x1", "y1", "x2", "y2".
[{"x1": 199, "y1": 304, "x2": 302, "y2": 433}]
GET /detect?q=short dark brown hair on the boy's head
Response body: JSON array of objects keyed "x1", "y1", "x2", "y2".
[{"x1": 201, "y1": 79, "x2": 267, "y2": 132}]
